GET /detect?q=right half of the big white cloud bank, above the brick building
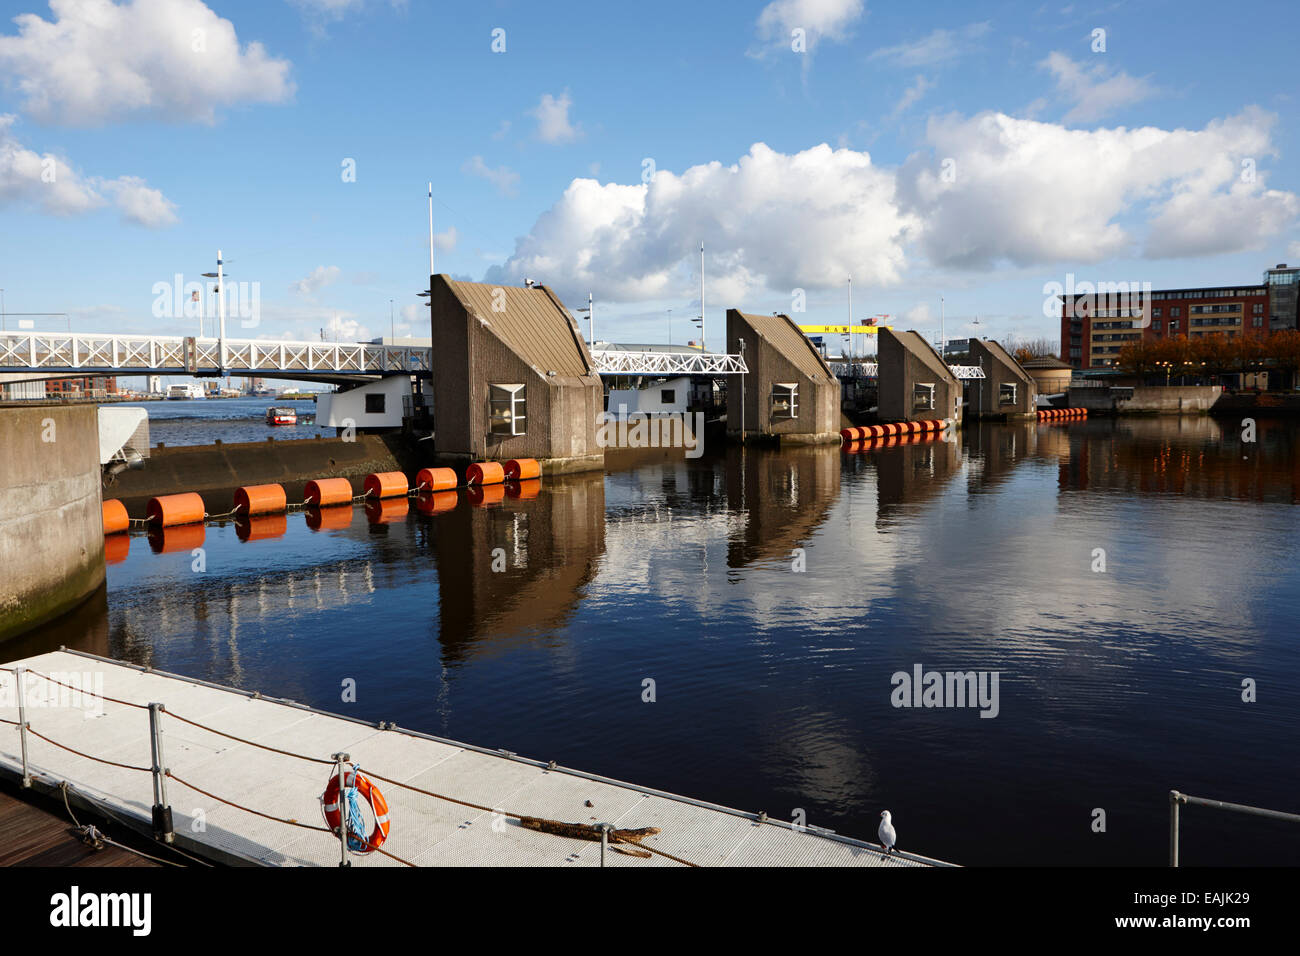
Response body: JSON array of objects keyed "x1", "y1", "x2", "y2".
[{"x1": 900, "y1": 108, "x2": 1296, "y2": 268}]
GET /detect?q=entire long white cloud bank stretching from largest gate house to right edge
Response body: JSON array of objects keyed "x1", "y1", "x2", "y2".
[{"x1": 485, "y1": 108, "x2": 1300, "y2": 303}]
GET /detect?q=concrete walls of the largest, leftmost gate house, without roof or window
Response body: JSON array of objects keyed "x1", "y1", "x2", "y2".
[{"x1": 430, "y1": 276, "x2": 605, "y2": 473}]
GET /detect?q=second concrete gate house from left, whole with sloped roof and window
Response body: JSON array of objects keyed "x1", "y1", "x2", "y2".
[{"x1": 727, "y1": 308, "x2": 840, "y2": 444}]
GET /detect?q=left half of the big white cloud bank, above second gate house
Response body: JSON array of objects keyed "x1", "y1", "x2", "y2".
[{"x1": 488, "y1": 143, "x2": 918, "y2": 300}]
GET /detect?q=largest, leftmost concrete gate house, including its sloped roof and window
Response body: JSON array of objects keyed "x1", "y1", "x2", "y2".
[{"x1": 430, "y1": 276, "x2": 605, "y2": 473}]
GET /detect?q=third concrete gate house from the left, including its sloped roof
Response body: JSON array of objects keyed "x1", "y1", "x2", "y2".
[{"x1": 876, "y1": 328, "x2": 962, "y2": 423}]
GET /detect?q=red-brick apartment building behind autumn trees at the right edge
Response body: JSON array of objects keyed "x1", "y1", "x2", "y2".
[{"x1": 1061, "y1": 263, "x2": 1300, "y2": 369}]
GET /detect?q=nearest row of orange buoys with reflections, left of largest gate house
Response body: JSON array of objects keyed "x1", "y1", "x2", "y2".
[{"x1": 101, "y1": 458, "x2": 542, "y2": 563}]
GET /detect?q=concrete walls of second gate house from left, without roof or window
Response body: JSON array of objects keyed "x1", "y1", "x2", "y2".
[{"x1": 727, "y1": 308, "x2": 840, "y2": 445}]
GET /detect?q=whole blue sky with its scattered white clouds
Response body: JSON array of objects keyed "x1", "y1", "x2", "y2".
[{"x1": 0, "y1": 0, "x2": 1300, "y2": 369}]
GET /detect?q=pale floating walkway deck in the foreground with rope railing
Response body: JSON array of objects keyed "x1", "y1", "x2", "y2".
[{"x1": 0, "y1": 652, "x2": 944, "y2": 866}]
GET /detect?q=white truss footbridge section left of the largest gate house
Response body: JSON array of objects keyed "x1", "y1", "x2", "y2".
[{"x1": 0, "y1": 332, "x2": 432, "y2": 382}]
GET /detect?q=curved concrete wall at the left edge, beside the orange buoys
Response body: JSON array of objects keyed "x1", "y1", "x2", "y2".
[{"x1": 0, "y1": 405, "x2": 104, "y2": 640}]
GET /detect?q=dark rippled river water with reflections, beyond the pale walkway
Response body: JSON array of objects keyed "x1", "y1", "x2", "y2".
[{"x1": 5, "y1": 419, "x2": 1300, "y2": 865}]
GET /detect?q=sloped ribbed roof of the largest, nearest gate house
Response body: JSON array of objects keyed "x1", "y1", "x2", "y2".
[{"x1": 447, "y1": 278, "x2": 594, "y2": 376}]
